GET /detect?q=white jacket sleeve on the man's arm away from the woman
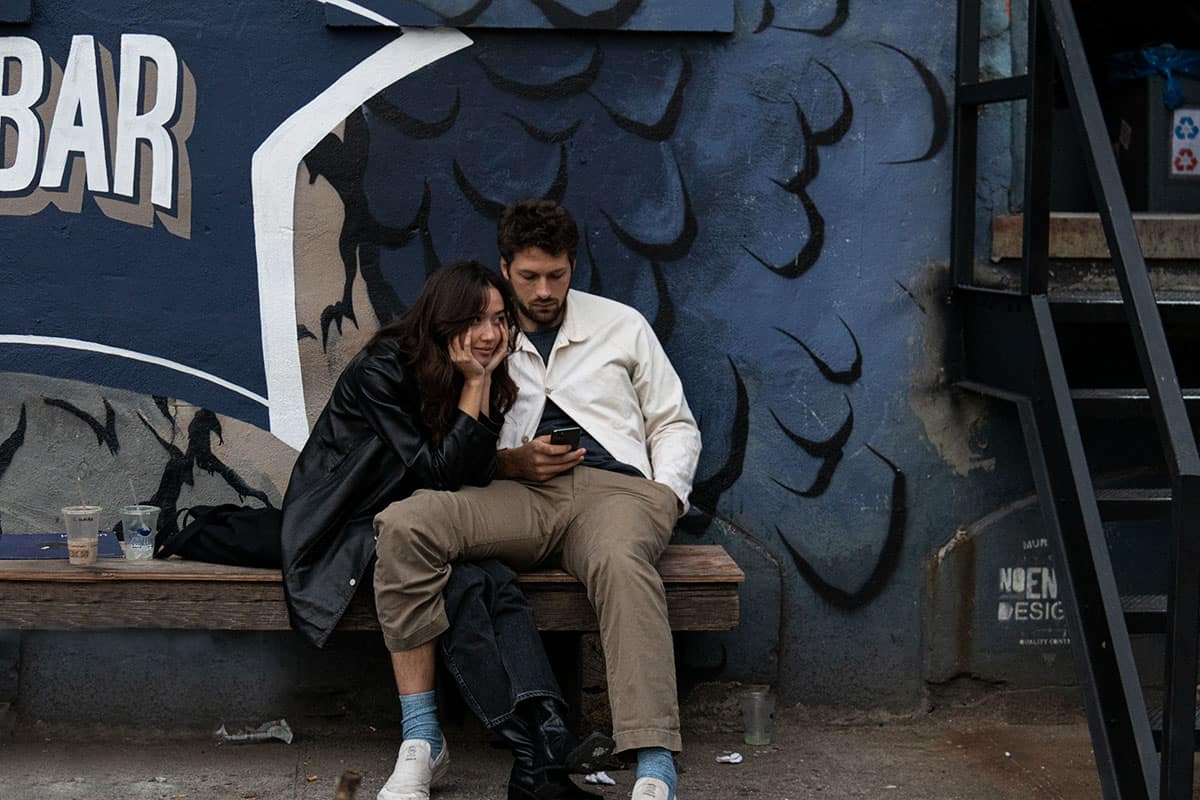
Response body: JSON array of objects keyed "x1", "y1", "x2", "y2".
[{"x1": 631, "y1": 314, "x2": 700, "y2": 512}]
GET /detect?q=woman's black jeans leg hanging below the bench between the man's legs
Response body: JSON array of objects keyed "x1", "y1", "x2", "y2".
[{"x1": 438, "y1": 559, "x2": 563, "y2": 728}]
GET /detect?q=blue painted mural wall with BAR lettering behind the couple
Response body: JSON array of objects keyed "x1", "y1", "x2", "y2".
[{"x1": 0, "y1": 0, "x2": 1028, "y2": 708}]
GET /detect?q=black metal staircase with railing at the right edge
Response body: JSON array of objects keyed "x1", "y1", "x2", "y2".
[{"x1": 952, "y1": 0, "x2": 1200, "y2": 800}]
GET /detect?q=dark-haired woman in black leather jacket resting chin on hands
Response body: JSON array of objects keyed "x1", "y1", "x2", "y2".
[{"x1": 276, "y1": 261, "x2": 612, "y2": 798}]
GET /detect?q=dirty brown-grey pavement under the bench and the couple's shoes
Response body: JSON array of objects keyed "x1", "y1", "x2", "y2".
[{"x1": 0, "y1": 696, "x2": 1099, "y2": 800}]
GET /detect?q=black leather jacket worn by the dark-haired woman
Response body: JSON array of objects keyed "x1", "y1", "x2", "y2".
[{"x1": 283, "y1": 339, "x2": 502, "y2": 646}]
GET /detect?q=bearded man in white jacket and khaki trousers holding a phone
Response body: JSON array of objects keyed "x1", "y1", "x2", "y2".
[{"x1": 374, "y1": 200, "x2": 700, "y2": 800}]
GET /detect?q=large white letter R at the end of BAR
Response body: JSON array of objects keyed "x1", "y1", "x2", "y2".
[{"x1": 113, "y1": 34, "x2": 179, "y2": 209}]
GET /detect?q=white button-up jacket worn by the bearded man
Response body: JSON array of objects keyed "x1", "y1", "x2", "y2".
[{"x1": 499, "y1": 289, "x2": 700, "y2": 510}]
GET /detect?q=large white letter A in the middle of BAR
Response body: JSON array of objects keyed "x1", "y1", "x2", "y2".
[{"x1": 41, "y1": 36, "x2": 108, "y2": 193}]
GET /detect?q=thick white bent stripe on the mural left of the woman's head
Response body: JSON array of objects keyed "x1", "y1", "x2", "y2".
[{"x1": 251, "y1": 28, "x2": 472, "y2": 450}]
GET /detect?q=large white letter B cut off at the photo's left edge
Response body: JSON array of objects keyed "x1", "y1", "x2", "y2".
[{"x1": 0, "y1": 36, "x2": 46, "y2": 192}]
